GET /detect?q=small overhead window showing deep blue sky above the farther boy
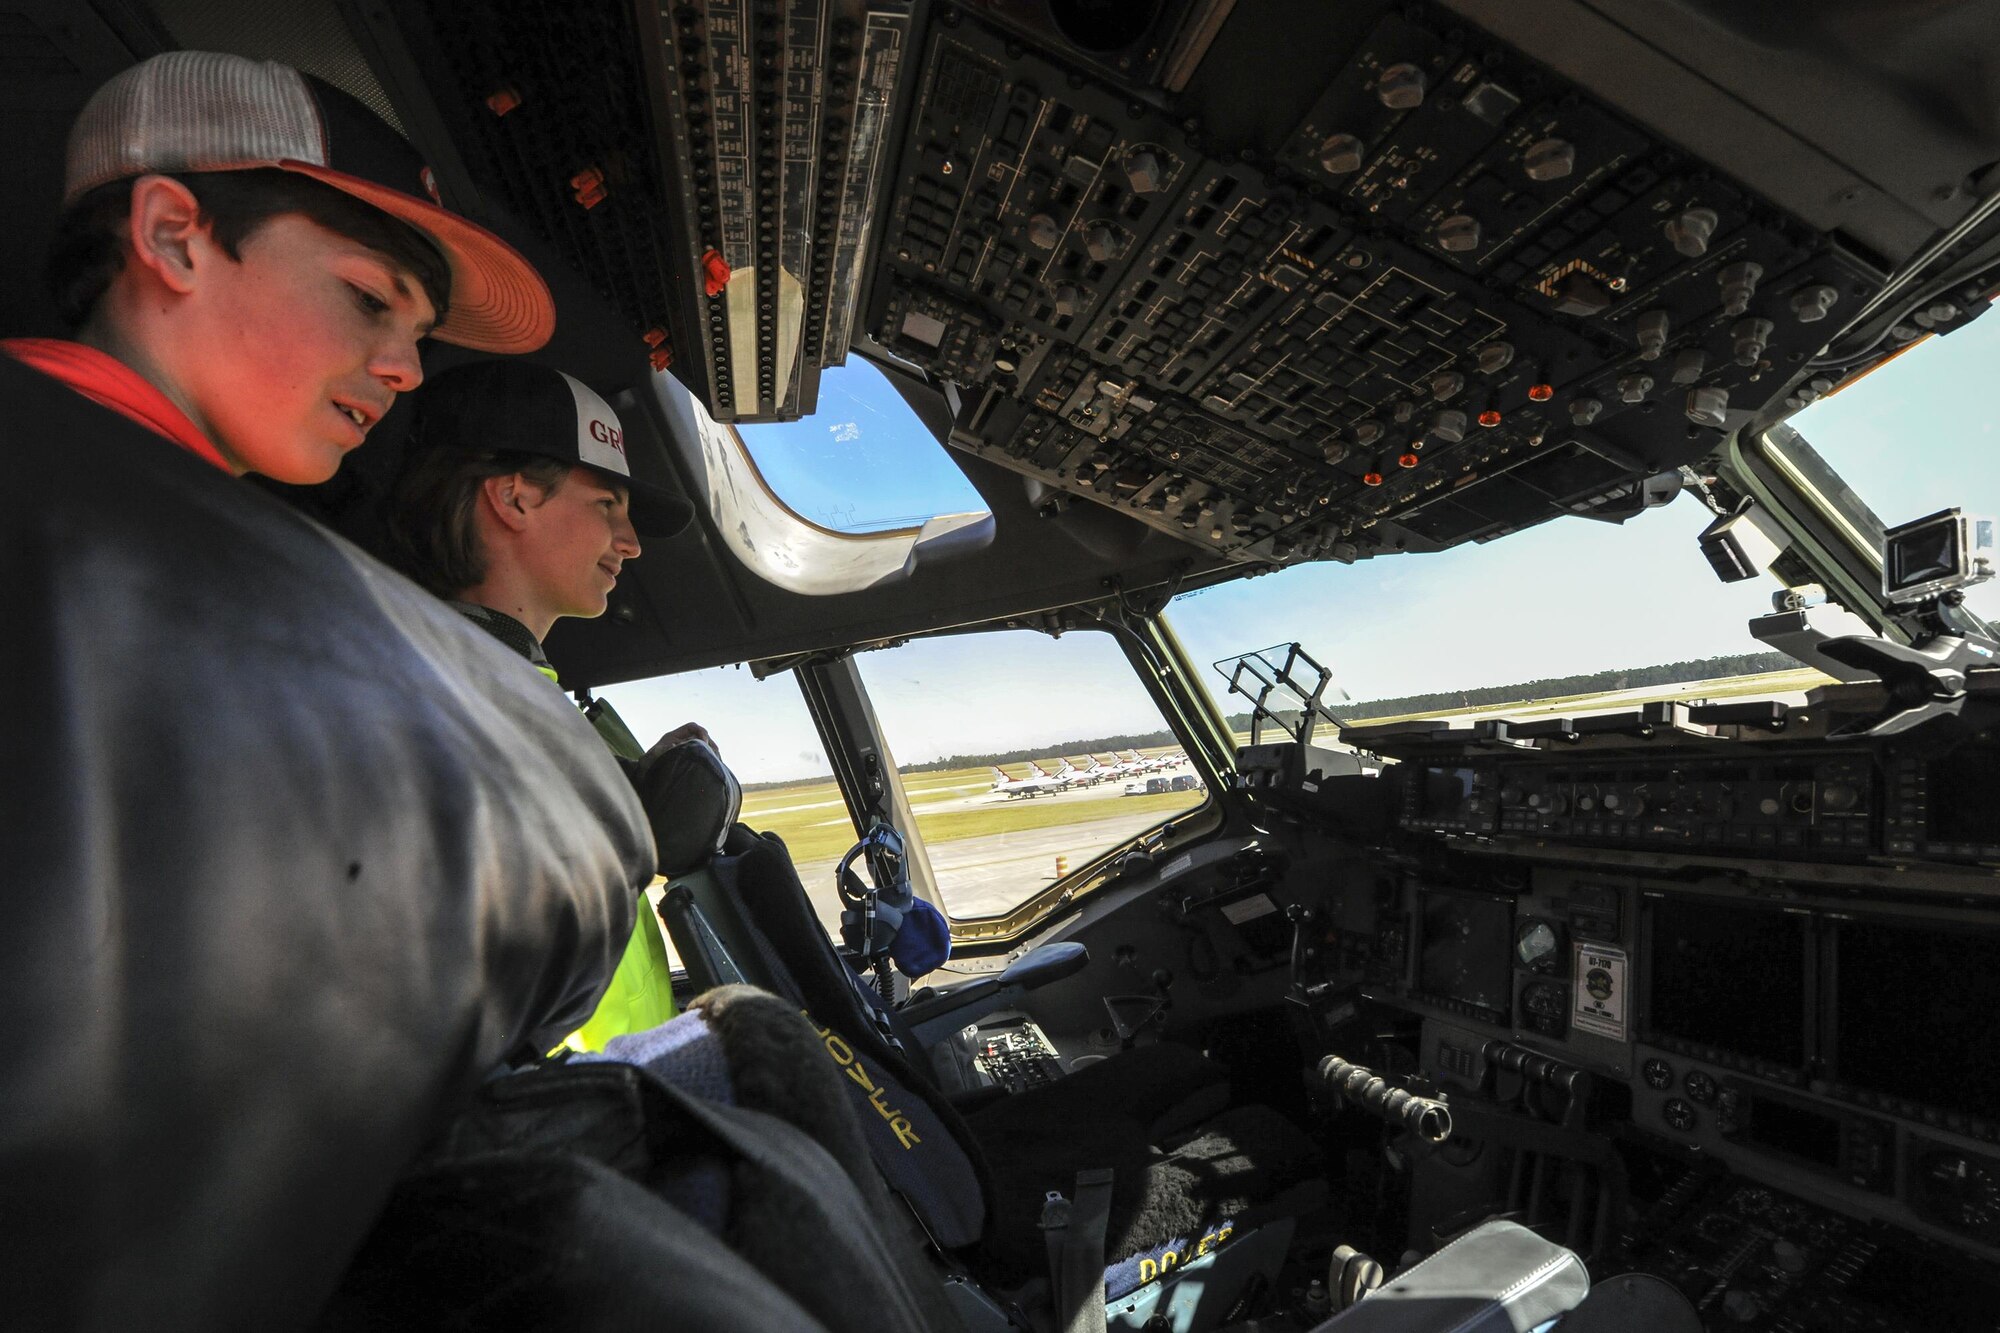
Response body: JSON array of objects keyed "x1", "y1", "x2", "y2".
[{"x1": 736, "y1": 356, "x2": 986, "y2": 532}]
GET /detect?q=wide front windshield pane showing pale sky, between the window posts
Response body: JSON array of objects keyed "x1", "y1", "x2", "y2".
[{"x1": 1168, "y1": 492, "x2": 1792, "y2": 728}]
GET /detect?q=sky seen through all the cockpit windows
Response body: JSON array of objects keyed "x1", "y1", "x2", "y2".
[{"x1": 612, "y1": 314, "x2": 2000, "y2": 783}]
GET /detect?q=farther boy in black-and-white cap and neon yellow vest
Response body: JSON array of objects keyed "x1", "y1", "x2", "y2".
[{"x1": 388, "y1": 360, "x2": 714, "y2": 1051}]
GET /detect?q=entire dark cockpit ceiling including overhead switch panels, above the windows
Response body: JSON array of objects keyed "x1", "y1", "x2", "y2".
[{"x1": 11, "y1": 0, "x2": 2000, "y2": 683}]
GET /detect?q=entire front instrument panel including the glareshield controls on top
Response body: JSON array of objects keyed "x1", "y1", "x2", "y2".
[{"x1": 1248, "y1": 705, "x2": 2000, "y2": 1288}]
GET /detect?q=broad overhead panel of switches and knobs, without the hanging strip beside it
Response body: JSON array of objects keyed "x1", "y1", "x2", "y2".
[{"x1": 862, "y1": 0, "x2": 1878, "y2": 562}]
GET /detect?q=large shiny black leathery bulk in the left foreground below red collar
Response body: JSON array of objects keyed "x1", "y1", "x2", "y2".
[{"x1": 0, "y1": 354, "x2": 652, "y2": 1329}]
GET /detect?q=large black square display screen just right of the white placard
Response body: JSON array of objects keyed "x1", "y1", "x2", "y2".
[{"x1": 1646, "y1": 899, "x2": 1808, "y2": 1069}]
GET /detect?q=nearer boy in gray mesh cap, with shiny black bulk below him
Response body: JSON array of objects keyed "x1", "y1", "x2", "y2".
[{"x1": 0, "y1": 52, "x2": 652, "y2": 1327}]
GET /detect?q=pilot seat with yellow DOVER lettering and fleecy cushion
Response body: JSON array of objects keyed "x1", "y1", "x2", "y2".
[{"x1": 642, "y1": 743, "x2": 1326, "y2": 1331}]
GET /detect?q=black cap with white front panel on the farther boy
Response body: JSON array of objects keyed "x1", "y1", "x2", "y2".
[{"x1": 412, "y1": 360, "x2": 694, "y2": 538}]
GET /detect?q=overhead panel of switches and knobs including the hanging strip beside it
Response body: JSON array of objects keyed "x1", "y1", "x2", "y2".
[{"x1": 398, "y1": 0, "x2": 1888, "y2": 562}]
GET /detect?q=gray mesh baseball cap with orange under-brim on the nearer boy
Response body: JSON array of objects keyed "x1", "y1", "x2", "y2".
[{"x1": 62, "y1": 50, "x2": 556, "y2": 352}]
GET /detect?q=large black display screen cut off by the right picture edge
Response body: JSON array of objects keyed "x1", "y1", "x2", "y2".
[{"x1": 1834, "y1": 921, "x2": 2000, "y2": 1121}]
